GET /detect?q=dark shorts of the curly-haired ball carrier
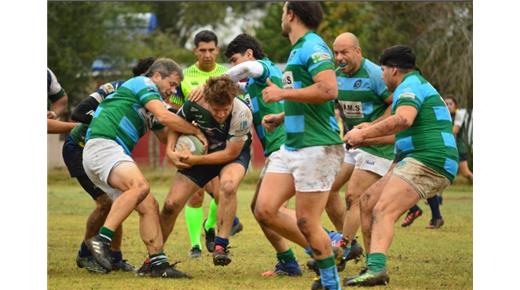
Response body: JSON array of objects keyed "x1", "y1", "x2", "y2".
[{"x1": 178, "y1": 146, "x2": 251, "y2": 188}]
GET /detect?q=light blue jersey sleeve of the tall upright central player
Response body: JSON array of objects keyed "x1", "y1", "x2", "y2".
[{"x1": 300, "y1": 43, "x2": 334, "y2": 77}]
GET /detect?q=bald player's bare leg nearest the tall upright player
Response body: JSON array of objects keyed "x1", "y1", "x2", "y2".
[{"x1": 325, "y1": 162, "x2": 354, "y2": 232}]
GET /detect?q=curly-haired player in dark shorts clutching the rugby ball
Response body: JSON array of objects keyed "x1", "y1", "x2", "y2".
[{"x1": 161, "y1": 76, "x2": 252, "y2": 266}]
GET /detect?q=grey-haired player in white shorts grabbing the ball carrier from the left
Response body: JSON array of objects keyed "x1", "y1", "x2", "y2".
[{"x1": 83, "y1": 58, "x2": 207, "y2": 278}]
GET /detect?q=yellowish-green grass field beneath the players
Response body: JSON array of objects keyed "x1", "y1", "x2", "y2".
[{"x1": 47, "y1": 170, "x2": 473, "y2": 290}]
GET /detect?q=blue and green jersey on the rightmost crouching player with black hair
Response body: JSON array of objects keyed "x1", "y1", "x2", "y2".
[{"x1": 392, "y1": 71, "x2": 459, "y2": 181}]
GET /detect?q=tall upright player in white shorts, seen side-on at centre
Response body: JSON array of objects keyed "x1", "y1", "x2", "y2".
[{"x1": 255, "y1": 1, "x2": 344, "y2": 289}]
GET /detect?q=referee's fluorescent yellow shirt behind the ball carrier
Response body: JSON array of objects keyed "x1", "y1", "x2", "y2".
[{"x1": 170, "y1": 63, "x2": 227, "y2": 106}]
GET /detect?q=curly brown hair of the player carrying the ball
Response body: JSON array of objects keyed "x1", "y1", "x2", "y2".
[{"x1": 204, "y1": 75, "x2": 240, "y2": 106}]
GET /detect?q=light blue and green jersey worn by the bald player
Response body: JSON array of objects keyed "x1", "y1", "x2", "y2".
[{"x1": 336, "y1": 58, "x2": 394, "y2": 160}]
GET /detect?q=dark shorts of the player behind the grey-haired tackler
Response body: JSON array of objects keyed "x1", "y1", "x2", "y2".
[{"x1": 62, "y1": 136, "x2": 104, "y2": 200}]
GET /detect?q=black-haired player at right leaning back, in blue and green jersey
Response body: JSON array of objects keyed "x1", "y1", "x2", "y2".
[{"x1": 345, "y1": 45, "x2": 458, "y2": 286}]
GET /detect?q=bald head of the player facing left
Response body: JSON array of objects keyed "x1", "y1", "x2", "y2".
[{"x1": 332, "y1": 32, "x2": 363, "y2": 75}]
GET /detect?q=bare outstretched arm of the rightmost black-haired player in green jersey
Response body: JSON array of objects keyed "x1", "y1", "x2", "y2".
[{"x1": 345, "y1": 105, "x2": 417, "y2": 147}]
